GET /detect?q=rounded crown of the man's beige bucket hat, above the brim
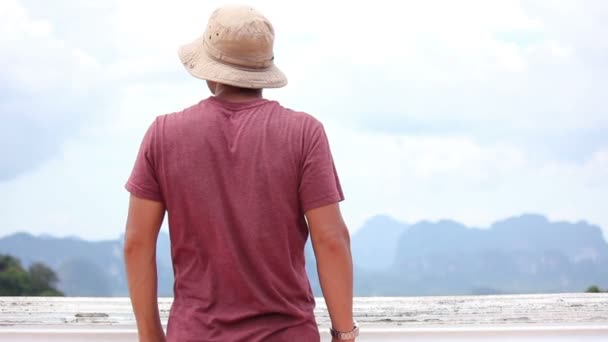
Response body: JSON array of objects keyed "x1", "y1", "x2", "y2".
[{"x1": 203, "y1": 6, "x2": 274, "y2": 69}]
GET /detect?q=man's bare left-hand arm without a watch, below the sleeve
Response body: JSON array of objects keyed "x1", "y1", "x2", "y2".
[{"x1": 124, "y1": 195, "x2": 165, "y2": 342}]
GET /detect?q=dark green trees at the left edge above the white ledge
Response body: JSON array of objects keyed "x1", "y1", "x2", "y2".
[{"x1": 0, "y1": 254, "x2": 63, "y2": 296}]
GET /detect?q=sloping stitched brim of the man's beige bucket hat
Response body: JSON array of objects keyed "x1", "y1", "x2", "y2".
[{"x1": 178, "y1": 37, "x2": 287, "y2": 89}]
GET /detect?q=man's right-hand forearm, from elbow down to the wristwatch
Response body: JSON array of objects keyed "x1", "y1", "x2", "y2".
[{"x1": 314, "y1": 232, "x2": 353, "y2": 332}]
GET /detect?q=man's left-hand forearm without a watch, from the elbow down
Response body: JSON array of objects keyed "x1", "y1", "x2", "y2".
[{"x1": 125, "y1": 246, "x2": 165, "y2": 342}]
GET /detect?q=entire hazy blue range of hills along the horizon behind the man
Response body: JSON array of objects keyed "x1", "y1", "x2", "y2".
[{"x1": 0, "y1": 215, "x2": 608, "y2": 296}]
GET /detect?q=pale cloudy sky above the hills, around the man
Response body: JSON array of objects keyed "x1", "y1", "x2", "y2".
[{"x1": 0, "y1": 0, "x2": 608, "y2": 239}]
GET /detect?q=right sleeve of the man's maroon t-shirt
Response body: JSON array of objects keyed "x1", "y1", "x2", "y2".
[{"x1": 299, "y1": 121, "x2": 344, "y2": 213}]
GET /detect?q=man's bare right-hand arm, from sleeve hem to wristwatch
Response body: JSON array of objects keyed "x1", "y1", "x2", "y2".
[{"x1": 306, "y1": 203, "x2": 353, "y2": 340}]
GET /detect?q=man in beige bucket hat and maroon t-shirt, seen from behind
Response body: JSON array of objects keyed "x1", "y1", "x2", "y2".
[{"x1": 124, "y1": 6, "x2": 358, "y2": 342}]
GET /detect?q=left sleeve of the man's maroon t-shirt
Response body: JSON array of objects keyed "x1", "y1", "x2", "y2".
[{"x1": 125, "y1": 120, "x2": 164, "y2": 202}]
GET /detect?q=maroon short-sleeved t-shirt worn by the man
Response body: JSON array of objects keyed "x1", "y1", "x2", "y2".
[{"x1": 126, "y1": 97, "x2": 344, "y2": 342}]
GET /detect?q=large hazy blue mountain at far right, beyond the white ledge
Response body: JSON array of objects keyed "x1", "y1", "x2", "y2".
[{"x1": 384, "y1": 215, "x2": 608, "y2": 295}]
